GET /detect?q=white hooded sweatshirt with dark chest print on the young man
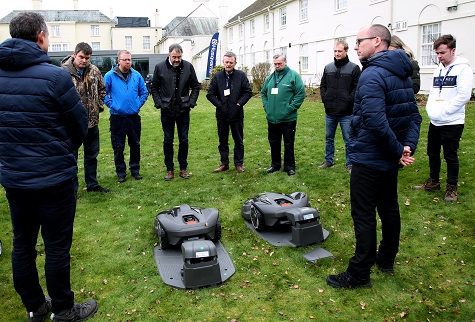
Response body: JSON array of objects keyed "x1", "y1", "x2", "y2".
[{"x1": 426, "y1": 57, "x2": 473, "y2": 126}]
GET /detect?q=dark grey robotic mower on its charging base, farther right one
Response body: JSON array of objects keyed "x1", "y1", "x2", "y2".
[{"x1": 241, "y1": 192, "x2": 328, "y2": 246}]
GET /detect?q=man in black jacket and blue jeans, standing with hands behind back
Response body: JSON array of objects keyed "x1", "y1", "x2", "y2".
[{"x1": 318, "y1": 40, "x2": 361, "y2": 172}]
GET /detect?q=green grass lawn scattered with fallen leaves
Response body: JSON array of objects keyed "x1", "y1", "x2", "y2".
[{"x1": 0, "y1": 92, "x2": 475, "y2": 321}]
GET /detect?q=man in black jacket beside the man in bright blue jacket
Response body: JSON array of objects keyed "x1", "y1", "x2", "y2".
[{"x1": 151, "y1": 44, "x2": 201, "y2": 181}]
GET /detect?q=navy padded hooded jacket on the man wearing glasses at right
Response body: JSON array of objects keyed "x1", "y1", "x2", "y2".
[{"x1": 348, "y1": 50, "x2": 422, "y2": 171}]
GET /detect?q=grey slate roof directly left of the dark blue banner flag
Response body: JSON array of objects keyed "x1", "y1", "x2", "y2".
[{"x1": 163, "y1": 17, "x2": 219, "y2": 37}]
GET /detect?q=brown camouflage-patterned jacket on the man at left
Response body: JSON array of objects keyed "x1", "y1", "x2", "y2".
[{"x1": 61, "y1": 56, "x2": 106, "y2": 128}]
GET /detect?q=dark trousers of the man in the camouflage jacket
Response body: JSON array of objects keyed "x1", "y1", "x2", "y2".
[{"x1": 76, "y1": 126, "x2": 99, "y2": 188}]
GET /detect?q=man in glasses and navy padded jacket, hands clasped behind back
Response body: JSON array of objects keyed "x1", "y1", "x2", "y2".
[{"x1": 327, "y1": 24, "x2": 422, "y2": 288}]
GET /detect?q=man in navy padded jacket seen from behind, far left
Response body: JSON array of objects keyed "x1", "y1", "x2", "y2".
[{"x1": 0, "y1": 12, "x2": 97, "y2": 321}]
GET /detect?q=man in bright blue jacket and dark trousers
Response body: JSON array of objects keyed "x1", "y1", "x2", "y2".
[{"x1": 104, "y1": 50, "x2": 148, "y2": 183}]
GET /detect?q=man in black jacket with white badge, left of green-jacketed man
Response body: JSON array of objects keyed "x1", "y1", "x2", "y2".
[{"x1": 206, "y1": 52, "x2": 252, "y2": 173}]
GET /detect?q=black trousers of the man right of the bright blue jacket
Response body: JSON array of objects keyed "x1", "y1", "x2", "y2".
[{"x1": 161, "y1": 111, "x2": 190, "y2": 171}]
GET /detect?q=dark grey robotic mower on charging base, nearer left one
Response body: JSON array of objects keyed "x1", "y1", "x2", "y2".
[{"x1": 154, "y1": 204, "x2": 235, "y2": 289}]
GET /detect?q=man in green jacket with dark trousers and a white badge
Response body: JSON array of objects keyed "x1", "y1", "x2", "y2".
[{"x1": 261, "y1": 54, "x2": 305, "y2": 176}]
